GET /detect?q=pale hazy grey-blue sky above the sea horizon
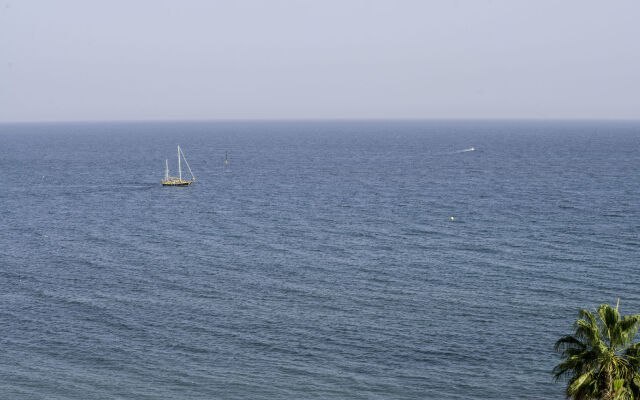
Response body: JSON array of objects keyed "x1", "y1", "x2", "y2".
[{"x1": 0, "y1": 0, "x2": 640, "y2": 121}]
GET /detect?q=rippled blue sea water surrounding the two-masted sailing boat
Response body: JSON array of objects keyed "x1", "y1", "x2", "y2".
[{"x1": 0, "y1": 121, "x2": 640, "y2": 399}]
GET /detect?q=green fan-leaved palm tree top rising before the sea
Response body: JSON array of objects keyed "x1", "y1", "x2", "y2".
[{"x1": 553, "y1": 299, "x2": 640, "y2": 400}]
